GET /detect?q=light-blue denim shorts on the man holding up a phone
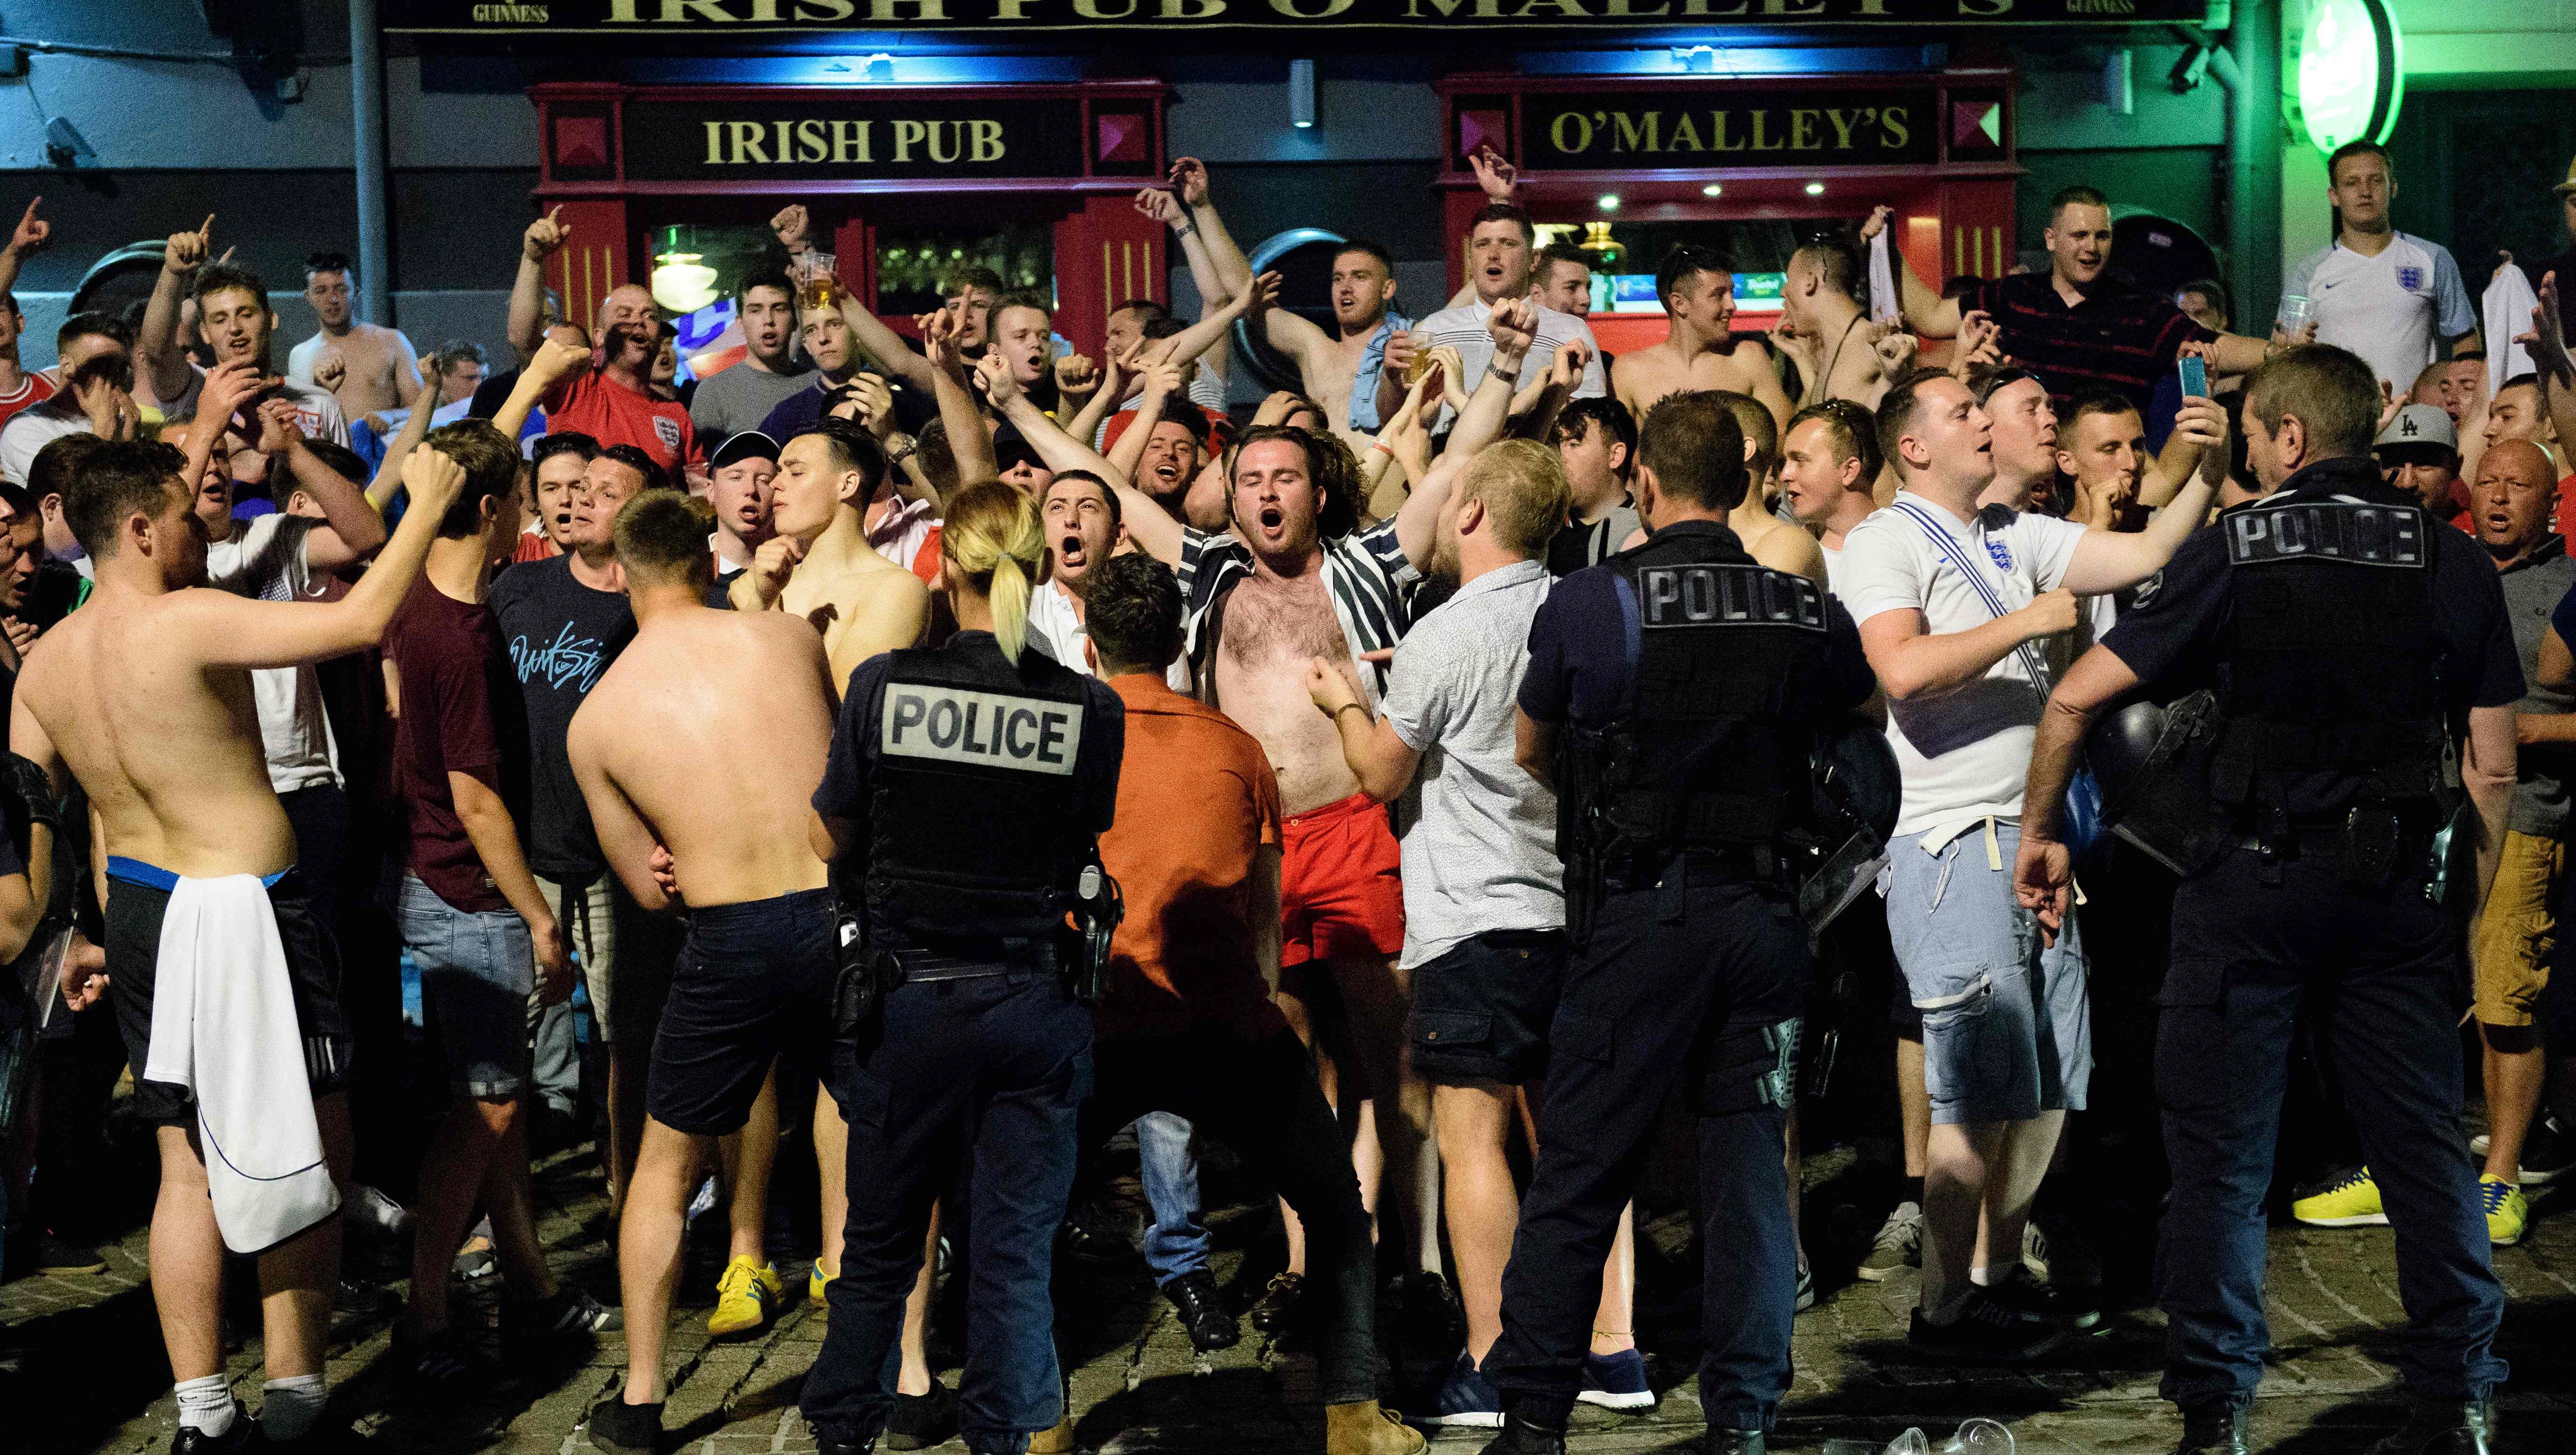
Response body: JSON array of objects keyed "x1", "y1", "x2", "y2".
[{"x1": 1881, "y1": 819, "x2": 2092, "y2": 1125}]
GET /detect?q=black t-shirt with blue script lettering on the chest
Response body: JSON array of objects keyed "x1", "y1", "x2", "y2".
[{"x1": 492, "y1": 556, "x2": 636, "y2": 881}]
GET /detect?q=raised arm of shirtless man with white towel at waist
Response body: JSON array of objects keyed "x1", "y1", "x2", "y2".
[{"x1": 170, "y1": 451, "x2": 466, "y2": 667}]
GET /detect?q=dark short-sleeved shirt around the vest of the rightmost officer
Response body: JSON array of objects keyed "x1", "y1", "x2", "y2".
[{"x1": 2102, "y1": 458, "x2": 2522, "y2": 811}]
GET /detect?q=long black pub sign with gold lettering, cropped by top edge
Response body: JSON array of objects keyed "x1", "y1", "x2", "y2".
[{"x1": 384, "y1": 0, "x2": 2208, "y2": 41}]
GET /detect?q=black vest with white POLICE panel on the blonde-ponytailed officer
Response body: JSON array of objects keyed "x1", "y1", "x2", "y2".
[{"x1": 868, "y1": 646, "x2": 1092, "y2": 948}]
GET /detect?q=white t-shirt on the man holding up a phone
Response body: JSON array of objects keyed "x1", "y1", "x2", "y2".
[{"x1": 1829, "y1": 489, "x2": 2084, "y2": 834}]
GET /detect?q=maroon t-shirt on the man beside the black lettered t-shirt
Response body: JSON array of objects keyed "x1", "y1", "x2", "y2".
[{"x1": 384, "y1": 577, "x2": 526, "y2": 912}]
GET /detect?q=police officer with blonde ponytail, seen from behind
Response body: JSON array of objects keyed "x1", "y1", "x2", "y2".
[{"x1": 804, "y1": 484, "x2": 1126, "y2": 1455}]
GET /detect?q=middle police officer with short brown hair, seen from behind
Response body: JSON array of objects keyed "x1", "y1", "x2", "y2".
[{"x1": 1481, "y1": 392, "x2": 1873, "y2": 1455}]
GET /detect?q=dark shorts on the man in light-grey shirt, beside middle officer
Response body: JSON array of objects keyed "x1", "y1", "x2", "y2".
[{"x1": 1404, "y1": 930, "x2": 1566, "y2": 1087}]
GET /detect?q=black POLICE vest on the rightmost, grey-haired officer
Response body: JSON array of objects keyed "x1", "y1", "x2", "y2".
[{"x1": 2210, "y1": 497, "x2": 2447, "y2": 821}]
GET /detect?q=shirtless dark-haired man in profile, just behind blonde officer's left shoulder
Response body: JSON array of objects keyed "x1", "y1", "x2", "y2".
[{"x1": 729, "y1": 420, "x2": 930, "y2": 683}]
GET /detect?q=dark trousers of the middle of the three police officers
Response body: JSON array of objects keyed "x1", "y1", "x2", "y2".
[{"x1": 1481, "y1": 875, "x2": 1813, "y2": 1429}]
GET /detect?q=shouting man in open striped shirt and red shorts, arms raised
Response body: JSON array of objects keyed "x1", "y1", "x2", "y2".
[{"x1": 1113, "y1": 299, "x2": 1543, "y2": 1321}]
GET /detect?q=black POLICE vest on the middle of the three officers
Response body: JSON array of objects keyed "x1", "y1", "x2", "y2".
[{"x1": 1564, "y1": 533, "x2": 1827, "y2": 857}]
